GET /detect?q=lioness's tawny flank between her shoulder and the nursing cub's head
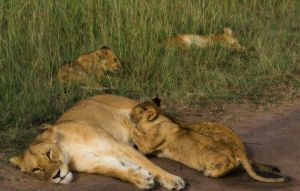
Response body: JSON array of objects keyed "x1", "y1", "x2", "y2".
[{"x1": 57, "y1": 95, "x2": 137, "y2": 143}]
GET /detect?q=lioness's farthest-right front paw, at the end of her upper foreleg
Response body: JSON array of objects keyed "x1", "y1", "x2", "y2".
[{"x1": 158, "y1": 175, "x2": 185, "y2": 190}]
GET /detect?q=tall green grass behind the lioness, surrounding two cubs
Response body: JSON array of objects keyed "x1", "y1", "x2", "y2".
[{"x1": 0, "y1": 0, "x2": 300, "y2": 155}]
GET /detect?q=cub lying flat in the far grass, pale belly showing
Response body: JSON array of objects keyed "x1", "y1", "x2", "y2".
[{"x1": 162, "y1": 28, "x2": 246, "y2": 52}]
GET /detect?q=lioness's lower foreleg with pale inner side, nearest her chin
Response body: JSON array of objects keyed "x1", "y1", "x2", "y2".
[{"x1": 89, "y1": 156, "x2": 155, "y2": 189}]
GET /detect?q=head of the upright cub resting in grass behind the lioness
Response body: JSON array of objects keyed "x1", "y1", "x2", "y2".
[{"x1": 92, "y1": 47, "x2": 121, "y2": 72}]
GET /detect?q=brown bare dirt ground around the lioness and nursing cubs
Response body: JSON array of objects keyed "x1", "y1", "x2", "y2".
[{"x1": 0, "y1": 101, "x2": 300, "y2": 191}]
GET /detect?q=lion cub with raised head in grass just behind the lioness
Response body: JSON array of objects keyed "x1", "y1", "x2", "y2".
[{"x1": 58, "y1": 47, "x2": 121, "y2": 86}]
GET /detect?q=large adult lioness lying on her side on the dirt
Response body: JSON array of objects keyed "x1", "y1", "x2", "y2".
[{"x1": 10, "y1": 95, "x2": 185, "y2": 190}]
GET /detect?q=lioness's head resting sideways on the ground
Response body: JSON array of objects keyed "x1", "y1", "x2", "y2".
[{"x1": 10, "y1": 126, "x2": 73, "y2": 184}]
